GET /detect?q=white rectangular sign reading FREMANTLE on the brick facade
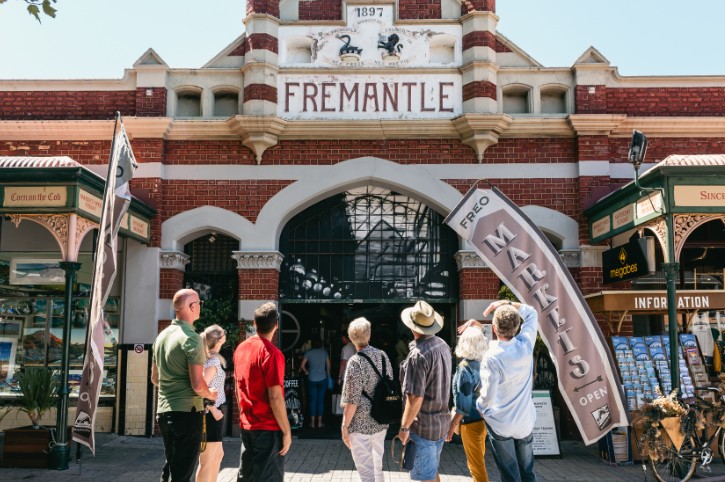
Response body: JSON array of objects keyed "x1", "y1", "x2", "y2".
[{"x1": 277, "y1": 74, "x2": 462, "y2": 119}]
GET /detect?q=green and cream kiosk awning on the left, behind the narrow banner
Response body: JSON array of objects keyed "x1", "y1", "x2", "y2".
[{"x1": 0, "y1": 156, "x2": 155, "y2": 259}]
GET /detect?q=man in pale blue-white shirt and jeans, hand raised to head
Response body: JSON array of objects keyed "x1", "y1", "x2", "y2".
[{"x1": 459, "y1": 300, "x2": 539, "y2": 482}]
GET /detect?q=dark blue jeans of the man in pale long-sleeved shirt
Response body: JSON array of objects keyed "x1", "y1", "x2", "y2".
[{"x1": 488, "y1": 427, "x2": 537, "y2": 482}]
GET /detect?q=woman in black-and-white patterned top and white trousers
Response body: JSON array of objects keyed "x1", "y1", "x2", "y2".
[{"x1": 340, "y1": 318, "x2": 393, "y2": 482}]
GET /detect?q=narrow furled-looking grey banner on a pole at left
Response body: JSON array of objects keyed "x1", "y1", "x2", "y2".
[{"x1": 73, "y1": 115, "x2": 138, "y2": 455}]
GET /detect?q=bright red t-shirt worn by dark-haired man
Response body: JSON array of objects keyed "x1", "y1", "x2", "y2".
[{"x1": 234, "y1": 336, "x2": 284, "y2": 430}]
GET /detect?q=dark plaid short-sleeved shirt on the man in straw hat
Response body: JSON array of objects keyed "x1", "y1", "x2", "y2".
[{"x1": 400, "y1": 336, "x2": 451, "y2": 440}]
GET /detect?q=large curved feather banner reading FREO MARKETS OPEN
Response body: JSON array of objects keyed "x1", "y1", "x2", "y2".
[{"x1": 445, "y1": 186, "x2": 629, "y2": 445}]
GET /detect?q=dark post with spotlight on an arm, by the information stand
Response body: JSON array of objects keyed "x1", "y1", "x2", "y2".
[{"x1": 627, "y1": 130, "x2": 680, "y2": 390}]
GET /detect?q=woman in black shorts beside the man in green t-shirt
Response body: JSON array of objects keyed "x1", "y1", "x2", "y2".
[{"x1": 196, "y1": 325, "x2": 227, "y2": 482}]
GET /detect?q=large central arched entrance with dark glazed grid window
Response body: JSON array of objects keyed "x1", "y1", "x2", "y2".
[{"x1": 279, "y1": 186, "x2": 459, "y2": 373}]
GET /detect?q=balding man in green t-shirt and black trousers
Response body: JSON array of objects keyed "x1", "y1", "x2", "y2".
[{"x1": 151, "y1": 289, "x2": 217, "y2": 482}]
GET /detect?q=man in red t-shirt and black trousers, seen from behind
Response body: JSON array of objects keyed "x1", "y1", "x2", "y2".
[{"x1": 234, "y1": 303, "x2": 292, "y2": 482}]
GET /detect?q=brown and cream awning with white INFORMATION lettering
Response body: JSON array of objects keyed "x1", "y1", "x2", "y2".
[{"x1": 584, "y1": 290, "x2": 725, "y2": 334}]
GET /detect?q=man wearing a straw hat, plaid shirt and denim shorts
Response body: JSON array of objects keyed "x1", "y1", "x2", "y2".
[{"x1": 398, "y1": 301, "x2": 451, "y2": 481}]
